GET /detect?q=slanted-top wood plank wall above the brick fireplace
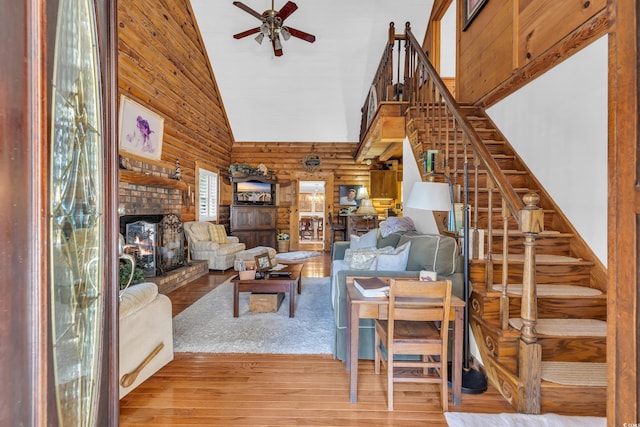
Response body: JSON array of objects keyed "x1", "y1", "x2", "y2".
[{"x1": 118, "y1": 0, "x2": 233, "y2": 223}]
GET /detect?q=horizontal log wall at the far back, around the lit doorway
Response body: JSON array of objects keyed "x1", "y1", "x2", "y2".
[{"x1": 231, "y1": 142, "x2": 371, "y2": 230}]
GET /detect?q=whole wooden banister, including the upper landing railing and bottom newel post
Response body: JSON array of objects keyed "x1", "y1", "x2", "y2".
[{"x1": 361, "y1": 22, "x2": 543, "y2": 413}]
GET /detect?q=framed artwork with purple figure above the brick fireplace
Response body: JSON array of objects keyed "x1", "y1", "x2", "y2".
[{"x1": 119, "y1": 95, "x2": 164, "y2": 160}]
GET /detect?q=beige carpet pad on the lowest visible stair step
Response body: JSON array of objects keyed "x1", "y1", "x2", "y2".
[{"x1": 542, "y1": 361, "x2": 607, "y2": 387}]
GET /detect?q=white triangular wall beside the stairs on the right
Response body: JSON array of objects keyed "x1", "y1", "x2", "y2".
[{"x1": 487, "y1": 36, "x2": 608, "y2": 265}]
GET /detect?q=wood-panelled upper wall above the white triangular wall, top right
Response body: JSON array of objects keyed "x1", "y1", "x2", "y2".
[{"x1": 456, "y1": 0, "x2": 607, "y2": 106}]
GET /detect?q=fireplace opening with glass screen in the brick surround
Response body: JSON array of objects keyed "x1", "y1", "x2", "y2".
[{"x1": 120, "y1": 214, "x2": 185, "y2": 277}]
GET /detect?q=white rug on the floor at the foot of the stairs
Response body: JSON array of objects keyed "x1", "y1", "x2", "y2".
[{"x1": 444, "y1": 412, "x2": 607, "y2": 427}]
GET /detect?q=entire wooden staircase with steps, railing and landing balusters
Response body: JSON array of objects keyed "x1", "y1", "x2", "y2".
[{"x1": 361, "y1": 24, "x2": 607, "y2": 416}]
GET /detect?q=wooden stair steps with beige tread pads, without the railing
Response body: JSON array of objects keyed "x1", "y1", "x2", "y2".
[{"x1": 405, "y1": 105, "x2": 607, "y2": 416}]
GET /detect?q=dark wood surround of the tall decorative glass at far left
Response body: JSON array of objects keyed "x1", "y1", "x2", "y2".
[{"x1": 0, "y1": 0, "x2": 119, "y2": 426}]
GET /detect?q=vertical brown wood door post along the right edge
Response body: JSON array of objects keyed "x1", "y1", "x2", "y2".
[{"x1": 607, "y1": 0, "x2": 640, "y2": 426}]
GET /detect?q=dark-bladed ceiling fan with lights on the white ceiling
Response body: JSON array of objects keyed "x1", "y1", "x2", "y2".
[{"x1": 233, "y1": 0, "x2": 316, "y2": 56}]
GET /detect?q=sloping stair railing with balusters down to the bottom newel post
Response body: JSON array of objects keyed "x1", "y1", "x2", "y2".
[{"x1": 404, "y1": 23, "x2": 543, "y2": 413}]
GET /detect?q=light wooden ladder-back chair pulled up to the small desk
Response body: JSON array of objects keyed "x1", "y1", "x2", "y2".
[{"x1": 374, "y1": 279, "x2": 451, "y2": 412}]
